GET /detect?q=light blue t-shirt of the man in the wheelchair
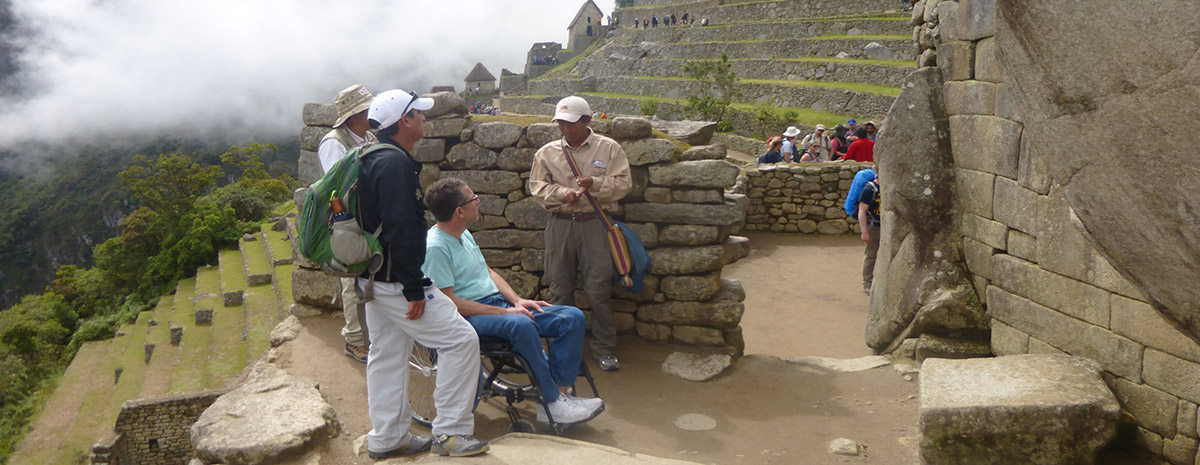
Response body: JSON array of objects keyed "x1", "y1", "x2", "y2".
[{"x1": 421, "y1": 225, "x2": 500, "y2": 301}]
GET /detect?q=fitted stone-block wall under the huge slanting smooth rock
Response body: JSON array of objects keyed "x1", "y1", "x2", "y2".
[{"x1": 912, "y1": 0, "x2": 1200, "y2": 465}]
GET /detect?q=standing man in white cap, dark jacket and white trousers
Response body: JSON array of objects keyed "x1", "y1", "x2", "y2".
[{"x1": 358, "y1": 90, "x2": 488, "y2": 459}]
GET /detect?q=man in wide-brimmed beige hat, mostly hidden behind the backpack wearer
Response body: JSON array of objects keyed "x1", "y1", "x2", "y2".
[{"x1": 317, "y1": 84, "x2": 374, "y2": 363}]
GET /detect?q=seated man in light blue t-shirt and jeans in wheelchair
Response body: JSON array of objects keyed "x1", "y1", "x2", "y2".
[{"x1": 421, "y1": 177, "x2": 604, "y2": 424}]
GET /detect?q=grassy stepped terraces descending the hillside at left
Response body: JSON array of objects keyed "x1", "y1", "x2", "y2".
[{"x1": 10, "y1": 216, "x2": 294, "y2": 465}]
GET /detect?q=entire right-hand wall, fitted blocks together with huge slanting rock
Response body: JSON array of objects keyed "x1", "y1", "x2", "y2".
[{"x1": 912, "y1": 0, "x2": 1200, "y2": 465}]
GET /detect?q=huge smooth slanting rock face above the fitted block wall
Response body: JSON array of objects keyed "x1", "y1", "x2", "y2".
[{"x1": 983, "y1": 0, "x2": 1200, "y2": 340}]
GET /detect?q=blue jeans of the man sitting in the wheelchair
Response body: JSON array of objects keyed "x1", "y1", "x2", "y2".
[{"x1": 467, "y1": 294, "x2": 587, "y2": 403}]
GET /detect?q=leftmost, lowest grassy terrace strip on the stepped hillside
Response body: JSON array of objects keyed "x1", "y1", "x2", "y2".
[{"x1": 8, "y1": 339, "x2": 114, "y2": 464}]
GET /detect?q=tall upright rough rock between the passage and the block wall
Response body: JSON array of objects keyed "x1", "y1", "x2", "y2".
[{"x1": 866, "y1": 67, "x2": 988, "y2": 352}]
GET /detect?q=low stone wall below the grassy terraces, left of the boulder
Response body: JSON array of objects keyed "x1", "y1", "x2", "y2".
[{"x1": 91, "y1": 388, "x2": 227, "y2": 465}]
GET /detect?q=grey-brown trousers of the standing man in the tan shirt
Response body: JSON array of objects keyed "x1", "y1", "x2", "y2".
[{"x1": 545, "y1": 217, "x2": 617, "y2": 355}]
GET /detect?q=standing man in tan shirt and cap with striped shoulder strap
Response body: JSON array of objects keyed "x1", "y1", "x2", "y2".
[{"x1": 529, "y1": 96, "x2": 632, "y2": 372}]
